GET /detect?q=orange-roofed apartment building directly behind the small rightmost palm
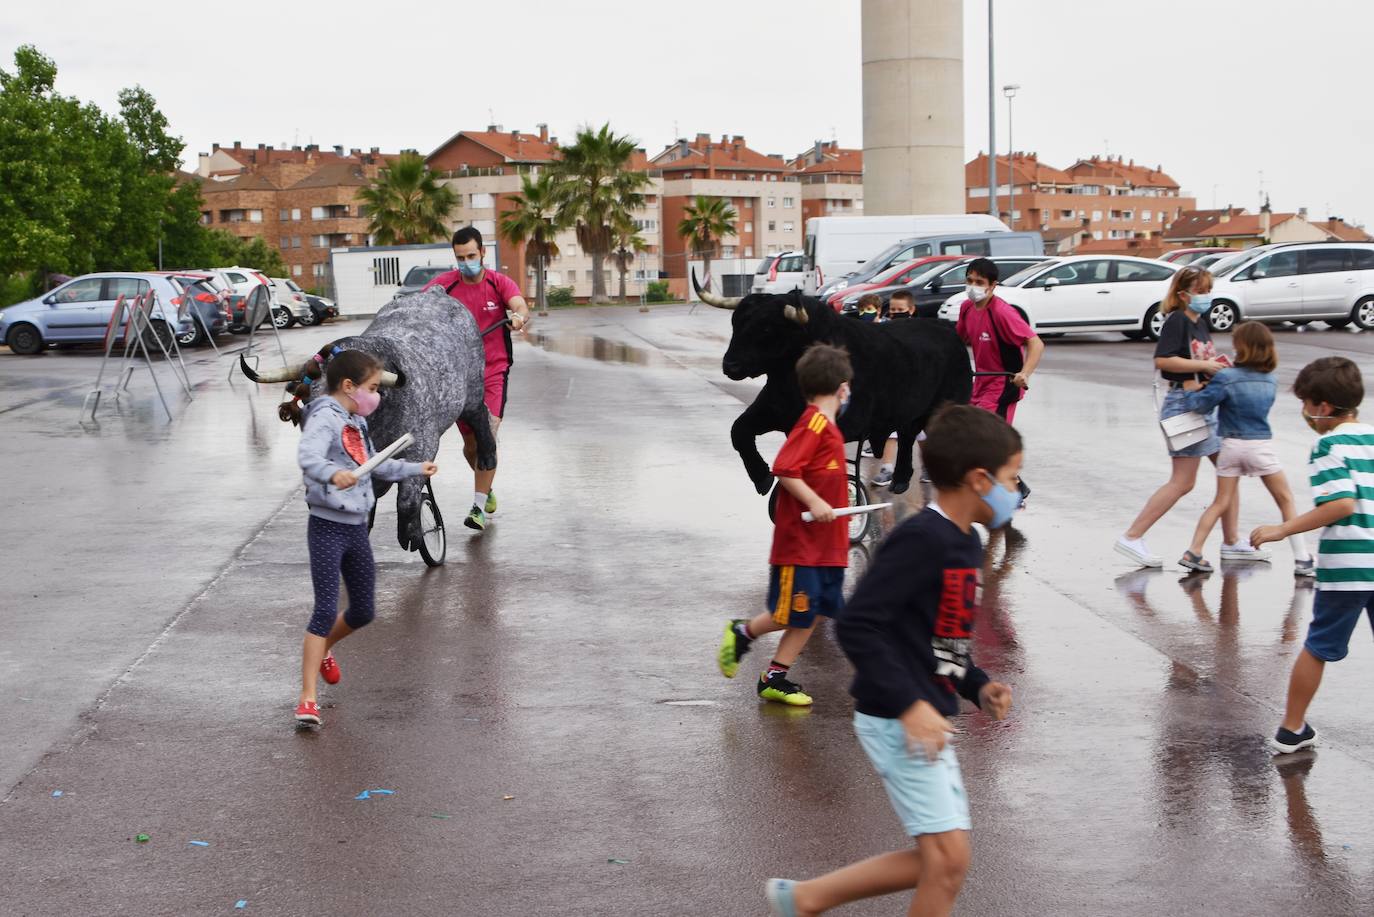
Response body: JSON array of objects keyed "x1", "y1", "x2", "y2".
[{"x1": 646, "y1": 133, "x2": 802, "y2": 279}]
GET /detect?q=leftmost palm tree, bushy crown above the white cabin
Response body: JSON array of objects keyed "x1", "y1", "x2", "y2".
[{"x1": 357, "y1": 153, "x2": 458, "y2": 245}]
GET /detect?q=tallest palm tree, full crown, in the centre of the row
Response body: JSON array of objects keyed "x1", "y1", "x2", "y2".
[{"x1": 552, "y1": 124, "x2": 650, "y2": 302}]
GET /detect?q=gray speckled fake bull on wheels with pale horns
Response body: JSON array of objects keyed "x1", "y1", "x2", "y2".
[{"x1": 239, "y1": 290, "x2": 496, "y2": 551}]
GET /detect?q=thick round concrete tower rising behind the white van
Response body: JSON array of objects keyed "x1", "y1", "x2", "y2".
[{"x1": 863, "y1": 0, "x2": 965, "y2": 216}]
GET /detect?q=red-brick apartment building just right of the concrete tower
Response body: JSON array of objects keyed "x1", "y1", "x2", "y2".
[{"x1": 965, "y1": 153, "x2": 1197, "y2": 247}]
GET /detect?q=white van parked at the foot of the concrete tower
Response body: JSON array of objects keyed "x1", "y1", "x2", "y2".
[{"x1": 802, "y1": 213, "x2": 1016, "y2": 296}]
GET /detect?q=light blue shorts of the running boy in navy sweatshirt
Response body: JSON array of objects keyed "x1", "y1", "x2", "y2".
[{"x1": 855, "y1": 711, "x2": 973, "y2": 837}]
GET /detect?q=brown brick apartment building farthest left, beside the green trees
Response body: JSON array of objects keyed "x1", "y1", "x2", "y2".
[{"x1": 196, "y1": 143, "x2": 393, "y2": 290}]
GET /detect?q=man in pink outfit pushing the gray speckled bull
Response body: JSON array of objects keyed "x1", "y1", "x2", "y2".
[{"x1": 425, "y1": 225, "x2": 529, "y2": 531}]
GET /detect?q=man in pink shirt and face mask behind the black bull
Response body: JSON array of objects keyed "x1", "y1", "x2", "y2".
[{"x1": 956, "y1": 258, "x2": 1044, "y2": 499}]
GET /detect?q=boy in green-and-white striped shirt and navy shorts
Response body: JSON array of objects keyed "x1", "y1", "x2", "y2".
[{"x1": 1250, "y1": 356, "x2": 1374, "y2": 755}]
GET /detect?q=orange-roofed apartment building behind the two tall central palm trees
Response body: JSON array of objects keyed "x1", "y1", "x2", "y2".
[{"x1": 426, "y1": 124, "x2": 662, "y2": 298}]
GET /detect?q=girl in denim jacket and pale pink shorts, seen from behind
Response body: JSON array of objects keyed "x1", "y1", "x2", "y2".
[{"x1": 1179, "y1": 322, "x2": 1316, "y2": 576}]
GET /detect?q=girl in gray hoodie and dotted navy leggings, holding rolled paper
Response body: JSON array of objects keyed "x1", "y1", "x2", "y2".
[{"x1": 295, "y1": 351, "x2": 438, "y2": 726}]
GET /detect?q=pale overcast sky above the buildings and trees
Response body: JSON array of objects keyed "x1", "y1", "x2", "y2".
[{"x1": 10, "y1": 0, "x2": 1374, "y2": 224}]
